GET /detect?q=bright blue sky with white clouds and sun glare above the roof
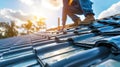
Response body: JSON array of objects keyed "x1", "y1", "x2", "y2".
[{"x1": 0, "y1": 0, "x2": 120, "y2": 28}]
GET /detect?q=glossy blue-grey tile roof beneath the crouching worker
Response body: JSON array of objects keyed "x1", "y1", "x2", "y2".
[{"x1": 0, "y1": 15, "x2": 120, "y2": 67}]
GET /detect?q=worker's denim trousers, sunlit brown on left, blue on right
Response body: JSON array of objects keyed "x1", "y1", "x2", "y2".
[{"x1": 67, "y1": 0, "x2": 94, "y2": 22}]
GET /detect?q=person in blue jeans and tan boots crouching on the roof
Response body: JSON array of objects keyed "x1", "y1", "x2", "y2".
[{"x1": 61, "y1": 0, "x2": 95, "y2": 30}]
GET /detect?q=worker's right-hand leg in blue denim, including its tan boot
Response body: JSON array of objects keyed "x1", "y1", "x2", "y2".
[{"x1": 79, "y1": 0, "x2": 95, "y2": 24}]
